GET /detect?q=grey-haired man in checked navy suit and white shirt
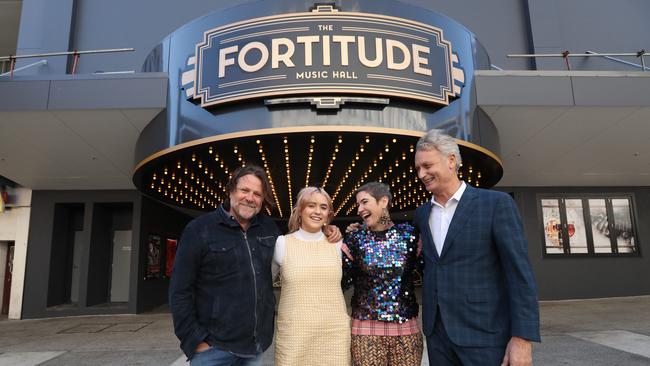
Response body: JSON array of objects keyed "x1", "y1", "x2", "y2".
[{"x1": 415, "y1": 130, "x2": 540, "y2": 366}]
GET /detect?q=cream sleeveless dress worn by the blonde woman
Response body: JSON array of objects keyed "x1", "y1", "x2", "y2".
[{"x1": 275, "y1": 231, "x2": 351, "y2": 366}]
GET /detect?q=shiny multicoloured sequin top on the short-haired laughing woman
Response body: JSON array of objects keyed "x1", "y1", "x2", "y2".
[{"x1": 342, "y1": 223, "x2": 423, "y2": 323}]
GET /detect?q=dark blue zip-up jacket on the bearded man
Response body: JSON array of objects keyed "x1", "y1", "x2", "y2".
[{"x1": 169, "y1": 207, "x2": 279, "y2": 358}]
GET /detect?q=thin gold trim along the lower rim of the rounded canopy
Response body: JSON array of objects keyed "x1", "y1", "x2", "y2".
[{"x1": 133, "y1": 126, "x2": 503, "y2": 175}]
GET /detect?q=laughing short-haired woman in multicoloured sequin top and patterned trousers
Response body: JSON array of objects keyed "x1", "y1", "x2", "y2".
[{"x1": 343, "y1": 182, "x2": 423, "y2": 366}]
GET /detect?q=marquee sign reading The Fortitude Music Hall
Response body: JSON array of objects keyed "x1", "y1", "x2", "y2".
[{"x1": 182, "y1": 5, "x2": 465, "y2": 107}]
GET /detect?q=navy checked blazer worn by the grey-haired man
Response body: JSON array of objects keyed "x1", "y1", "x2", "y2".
[{"x1": 414, "y1": 185, "x2": 540, "y2": 347}]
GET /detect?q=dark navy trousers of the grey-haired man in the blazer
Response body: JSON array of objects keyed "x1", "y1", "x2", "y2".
[{"x1": 427, "y1": 310, "x2": 505, "y2": 366}]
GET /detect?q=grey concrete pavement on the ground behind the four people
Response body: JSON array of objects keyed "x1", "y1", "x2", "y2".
[{"x1": 0, "y1": 296, "x2": 650, "y2": 366}]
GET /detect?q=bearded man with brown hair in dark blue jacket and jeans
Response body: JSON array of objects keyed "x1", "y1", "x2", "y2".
[{"x1": 169, "y1": 165, "x2": 341, "y2": 366}]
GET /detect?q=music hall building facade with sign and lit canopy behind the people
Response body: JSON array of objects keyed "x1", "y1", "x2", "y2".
[{"x1": 0, "y1": 0, "x2": 650, "y2": 318}]
